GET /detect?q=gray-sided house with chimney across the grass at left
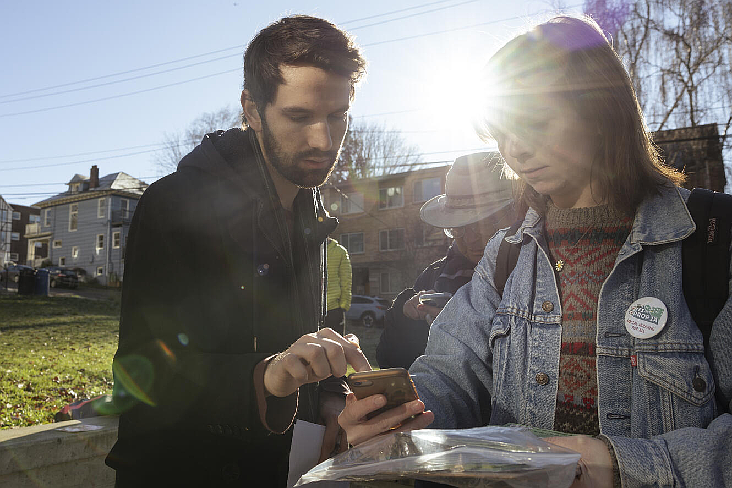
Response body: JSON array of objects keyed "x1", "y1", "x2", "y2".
[{"x1": 25, "y1": 166, "x2": 148, "y2": 285}]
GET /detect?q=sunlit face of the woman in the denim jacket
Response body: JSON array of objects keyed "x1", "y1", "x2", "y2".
[{"x1": 495, "y1": 95, "x2": 604, "y2": 208}]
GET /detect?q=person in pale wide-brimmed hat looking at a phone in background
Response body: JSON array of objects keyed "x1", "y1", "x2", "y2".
[{"x1": 376, "y1": 152, "x2": 516, "y2": 368}]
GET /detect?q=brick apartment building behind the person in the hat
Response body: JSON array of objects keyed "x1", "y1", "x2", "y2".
[{"x1": 321, "y1": 166, "x2": 450, "y2": 298}]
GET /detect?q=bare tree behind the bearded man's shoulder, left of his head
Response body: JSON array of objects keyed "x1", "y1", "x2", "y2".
[{"x1": 155, "y1": 106, "x2": 241, "y2": 174}]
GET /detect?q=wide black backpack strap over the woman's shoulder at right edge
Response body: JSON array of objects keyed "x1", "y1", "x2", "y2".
[{"x1": 682, "y1": 188, "x2": 732, "y2": 351}]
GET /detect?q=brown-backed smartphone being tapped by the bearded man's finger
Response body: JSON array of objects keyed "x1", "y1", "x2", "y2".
[{"x1": 348, "y1": 368, "x2": 419, "y2": 419}]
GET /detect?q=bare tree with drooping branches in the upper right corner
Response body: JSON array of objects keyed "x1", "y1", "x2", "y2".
[{"x1": 585, "y1": 0, "x2": 732, "y2": 136}]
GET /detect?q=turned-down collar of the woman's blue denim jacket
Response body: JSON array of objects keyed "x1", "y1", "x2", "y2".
[{"x1": 506, "y1": 187, "x2": 696, "y2": 245}]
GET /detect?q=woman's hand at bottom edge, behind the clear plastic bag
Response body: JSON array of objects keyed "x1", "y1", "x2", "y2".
[{"x1": 544, "y1": 435, "x2": 613, "y2": 488}]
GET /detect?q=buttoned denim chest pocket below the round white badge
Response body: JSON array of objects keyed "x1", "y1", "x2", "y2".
[{"x1": 635, "y1": 352, "x2": 716, "y2": 435}]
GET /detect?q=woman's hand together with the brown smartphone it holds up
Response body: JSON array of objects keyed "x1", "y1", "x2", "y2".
[{"x1": 338, "y1": 368, "x2": 434, "y2": 445}]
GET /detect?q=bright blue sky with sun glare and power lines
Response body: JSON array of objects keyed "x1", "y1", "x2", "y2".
[{"x1": 0, "y1": 0, "x2": 581, "y2": 205}]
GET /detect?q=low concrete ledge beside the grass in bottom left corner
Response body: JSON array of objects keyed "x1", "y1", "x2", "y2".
[{"x1": 0, "y1": 416, "x2": 118, "y2": 488}]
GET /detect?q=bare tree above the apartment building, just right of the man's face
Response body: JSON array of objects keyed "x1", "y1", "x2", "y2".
[{"x1": 330, "y1": 116, "x2": 421, "y2": 183}]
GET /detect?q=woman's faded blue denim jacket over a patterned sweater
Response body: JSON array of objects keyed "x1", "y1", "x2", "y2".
[{"x1": 410, "y1": 188, "x2": 732, "y2": 487}]
